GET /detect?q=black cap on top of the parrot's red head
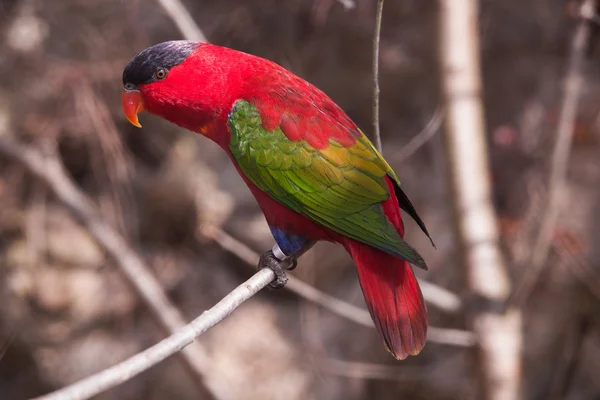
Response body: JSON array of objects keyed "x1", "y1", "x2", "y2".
[{"x1": 123, "y1": 40, "x2": 200, "y2": 89}]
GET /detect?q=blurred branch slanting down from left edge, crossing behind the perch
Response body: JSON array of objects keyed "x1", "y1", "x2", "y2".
[{"x1": 0, "y1": 137, "x2": 217, "y2": 396}]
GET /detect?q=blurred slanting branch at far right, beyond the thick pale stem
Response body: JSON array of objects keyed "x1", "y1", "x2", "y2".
[{"x1": 511, "y1": 0, "x2": 596, "y2": 304}]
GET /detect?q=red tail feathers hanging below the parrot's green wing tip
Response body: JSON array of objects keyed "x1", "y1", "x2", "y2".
[{"x1": 346, "y1": 240, "x2": 427, "y2": 360}]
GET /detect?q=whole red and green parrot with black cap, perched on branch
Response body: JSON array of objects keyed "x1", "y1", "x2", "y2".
[{"x1": 122, "y1": 41, "x2": 433, "y2": 359}]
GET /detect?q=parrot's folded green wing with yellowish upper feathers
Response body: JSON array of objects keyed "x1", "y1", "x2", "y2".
[{"x1": 229, "y1": 100, "x2": 427, "y2": 269}]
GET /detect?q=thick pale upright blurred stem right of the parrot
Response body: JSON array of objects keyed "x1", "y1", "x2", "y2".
[{"x1": 439, "y1": 0, "x2": 522, "y2": 400}]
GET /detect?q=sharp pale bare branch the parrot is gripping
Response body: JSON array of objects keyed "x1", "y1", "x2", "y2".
[{"x1": 37, "y1": 268, "x2": 275, "y2": 400}]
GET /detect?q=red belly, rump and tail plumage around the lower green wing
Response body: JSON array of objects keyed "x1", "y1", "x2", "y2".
[{"x1": 238, "y1": 162, "x2": 427, "y2": 360}]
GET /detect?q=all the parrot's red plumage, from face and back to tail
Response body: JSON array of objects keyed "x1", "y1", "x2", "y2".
[{"x1": 127, "y1": 44, "x2": 427, "y2": 359}]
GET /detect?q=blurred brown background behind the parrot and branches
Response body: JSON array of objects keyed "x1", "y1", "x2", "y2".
[{"x1": 0, "y1": 0, "x2": 600, "y2": 400}]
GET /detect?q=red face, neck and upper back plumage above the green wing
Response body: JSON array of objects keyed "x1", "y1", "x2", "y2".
[{"x1": 140, "y1": 44, "x2": 359, "y2": 152}]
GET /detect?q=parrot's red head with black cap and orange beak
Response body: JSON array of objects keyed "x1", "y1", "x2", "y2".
[{"x1": 122, "y1": 40, "x2": 237, "y2": 132}]
